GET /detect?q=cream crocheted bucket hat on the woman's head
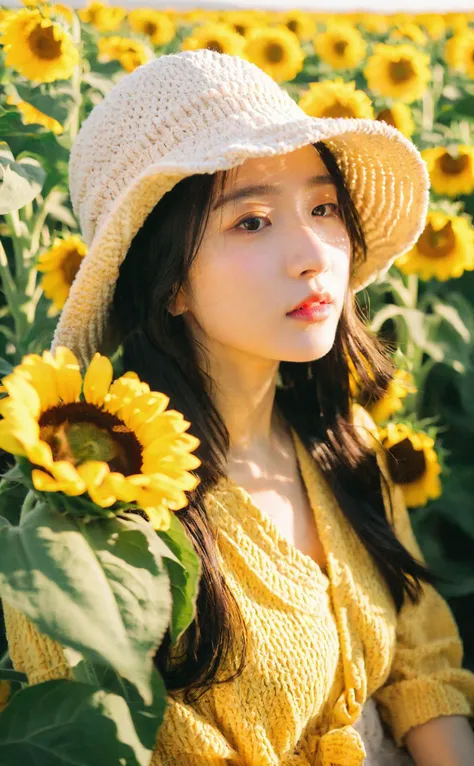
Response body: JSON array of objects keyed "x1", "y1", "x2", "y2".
[{"x1": 52, "y1": 50, "x2": 429, "y2": 367}]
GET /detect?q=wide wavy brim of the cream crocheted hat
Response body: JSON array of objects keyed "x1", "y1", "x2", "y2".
[{"x1": 52, "y1": 116, "x2": 430, "y2": 367}]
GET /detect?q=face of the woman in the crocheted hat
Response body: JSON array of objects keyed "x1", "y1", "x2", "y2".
[{"x1": 176, "y1": 146, "x2": 350, "y2": 362}]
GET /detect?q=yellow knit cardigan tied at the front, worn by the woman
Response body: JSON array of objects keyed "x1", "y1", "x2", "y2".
[{"x1": 4, "y1": 407, "x2": 474, "y2": 766}]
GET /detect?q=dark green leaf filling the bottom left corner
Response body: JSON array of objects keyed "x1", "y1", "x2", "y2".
[{"x1": 0, "y1": 679, "x2": 151, "y2": 766}]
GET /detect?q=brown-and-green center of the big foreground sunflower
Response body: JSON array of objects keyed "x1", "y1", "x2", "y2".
[{"x1": 39, "y1": 402, "x2": 142, "y2": 476}]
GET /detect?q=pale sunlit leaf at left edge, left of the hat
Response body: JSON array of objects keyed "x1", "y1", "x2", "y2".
[{"x1": 0, "y1": 141, "x2": 46, "y2": 215}]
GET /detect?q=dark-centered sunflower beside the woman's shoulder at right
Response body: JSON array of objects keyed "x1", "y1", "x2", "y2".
[{"x1": 379, "y1": 423, "x2": 442, "y2": 508}]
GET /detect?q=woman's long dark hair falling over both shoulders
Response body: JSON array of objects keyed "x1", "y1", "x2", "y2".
[{"x1": 113, "y1": 142, "x2": 432, "y2": 702}]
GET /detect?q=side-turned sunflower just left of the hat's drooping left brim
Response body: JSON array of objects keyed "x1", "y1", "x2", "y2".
[{"x1": 37, "y1": 234, "x2": 87, "y2": 311}]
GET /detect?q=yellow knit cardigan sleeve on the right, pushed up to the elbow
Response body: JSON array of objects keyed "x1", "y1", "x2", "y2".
[{"x1": 352, "y1": 411, "x2": 474, "y2": 745}]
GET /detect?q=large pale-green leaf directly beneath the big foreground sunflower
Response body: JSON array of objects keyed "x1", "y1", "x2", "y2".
[{"x1": 0, "y1": 503, "x2": 171, "y2": 704}]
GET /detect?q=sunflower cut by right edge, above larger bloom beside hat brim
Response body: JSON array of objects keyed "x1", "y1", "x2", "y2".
[{"x1": 421, "y1": 144, "x2": 474, "y2": 197}]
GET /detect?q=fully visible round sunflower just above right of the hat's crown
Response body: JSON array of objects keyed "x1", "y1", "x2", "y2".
[{"x1": 244, "y1": 25, "x2": 304, "y2": 82}]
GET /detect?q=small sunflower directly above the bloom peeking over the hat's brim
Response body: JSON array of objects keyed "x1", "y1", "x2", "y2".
[{"x1": 313, "y1": 22, "x2": 367, "y2": 69}]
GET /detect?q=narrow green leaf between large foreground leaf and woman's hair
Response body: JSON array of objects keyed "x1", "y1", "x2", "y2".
[{"x1": 157, "y1": 514, "x2": 202, "y2": 645}]
